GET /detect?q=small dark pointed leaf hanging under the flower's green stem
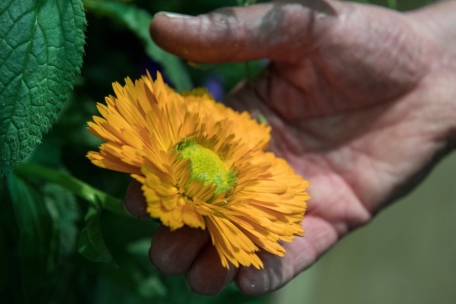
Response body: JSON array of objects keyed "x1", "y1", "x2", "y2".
[{"x1": 78, "y1": 206, "x2": 118, "y2": 267}]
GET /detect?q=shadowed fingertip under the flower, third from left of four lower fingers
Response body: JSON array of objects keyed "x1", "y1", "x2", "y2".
[{"x1": 185, "y1": 243, "x2": 238, "y2": 296}]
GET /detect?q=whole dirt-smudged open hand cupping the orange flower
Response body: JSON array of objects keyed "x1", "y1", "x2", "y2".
[{"x1": 125, "y1": 1, "x2": 456, "y2": 295}]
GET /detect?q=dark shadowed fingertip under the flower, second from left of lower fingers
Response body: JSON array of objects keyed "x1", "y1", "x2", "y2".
[{"x1": 149, "y1": 225, "x2": 209, "y2": 275}]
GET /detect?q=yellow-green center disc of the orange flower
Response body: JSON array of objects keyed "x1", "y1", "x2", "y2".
[{"x1": 177, "y1": 140, "x2": 236, "y2": 195}]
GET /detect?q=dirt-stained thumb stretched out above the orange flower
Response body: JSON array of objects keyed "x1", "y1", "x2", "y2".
[{"x1": 150, "y1": 1, "x2": 340, "y2": 63}]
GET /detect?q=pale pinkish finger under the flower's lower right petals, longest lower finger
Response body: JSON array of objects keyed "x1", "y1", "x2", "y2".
[{"x1": 235, "y1": 216, "x2": 338, "y2": 296}]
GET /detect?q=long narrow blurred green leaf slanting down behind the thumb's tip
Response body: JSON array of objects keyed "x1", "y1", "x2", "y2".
[{"x1": 84, "y1": 0, "x2": 193, "y2": 92}]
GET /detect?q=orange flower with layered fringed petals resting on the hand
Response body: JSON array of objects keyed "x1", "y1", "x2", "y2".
[{"x1": 87, "y1": 73, "x2": 310, "y2": 268}]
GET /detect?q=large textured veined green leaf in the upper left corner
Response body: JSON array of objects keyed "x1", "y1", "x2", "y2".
[{"x1": 0, "y1": 0, "x2": 86, "y2": 176}]
